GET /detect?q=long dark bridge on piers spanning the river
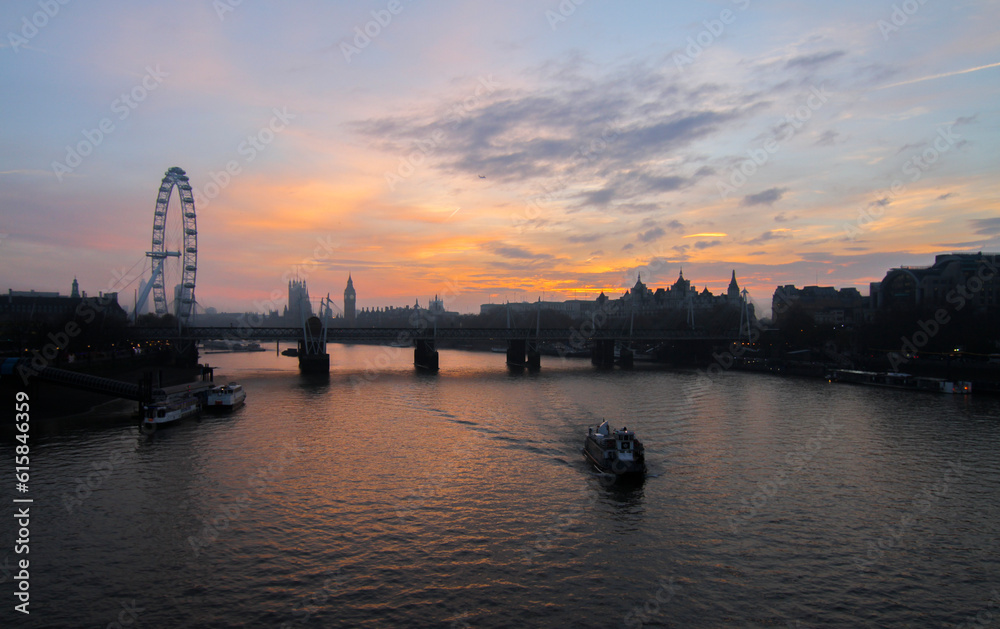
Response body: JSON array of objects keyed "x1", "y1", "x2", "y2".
[{"x1": 129, "y1": 324, "x2": 739, "y2": 371}]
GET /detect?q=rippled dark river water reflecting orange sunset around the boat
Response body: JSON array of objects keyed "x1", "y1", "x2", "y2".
[{"x1": 0, "y1": 345, "x2": 1000, "y2": 628}]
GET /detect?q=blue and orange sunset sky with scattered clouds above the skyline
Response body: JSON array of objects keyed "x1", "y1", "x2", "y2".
[{"x1": 0, "y1": 0, "x2": 1000, "y2": 312}]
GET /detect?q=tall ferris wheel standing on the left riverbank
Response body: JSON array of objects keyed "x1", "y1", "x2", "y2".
[{"x1": 136, "y1": 166, "x2": 198, "y2": 325}]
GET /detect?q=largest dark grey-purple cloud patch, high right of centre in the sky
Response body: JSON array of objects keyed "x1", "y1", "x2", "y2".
[{"x1": 350, "y1": 56, "x2": 752, "y2": 209}]
